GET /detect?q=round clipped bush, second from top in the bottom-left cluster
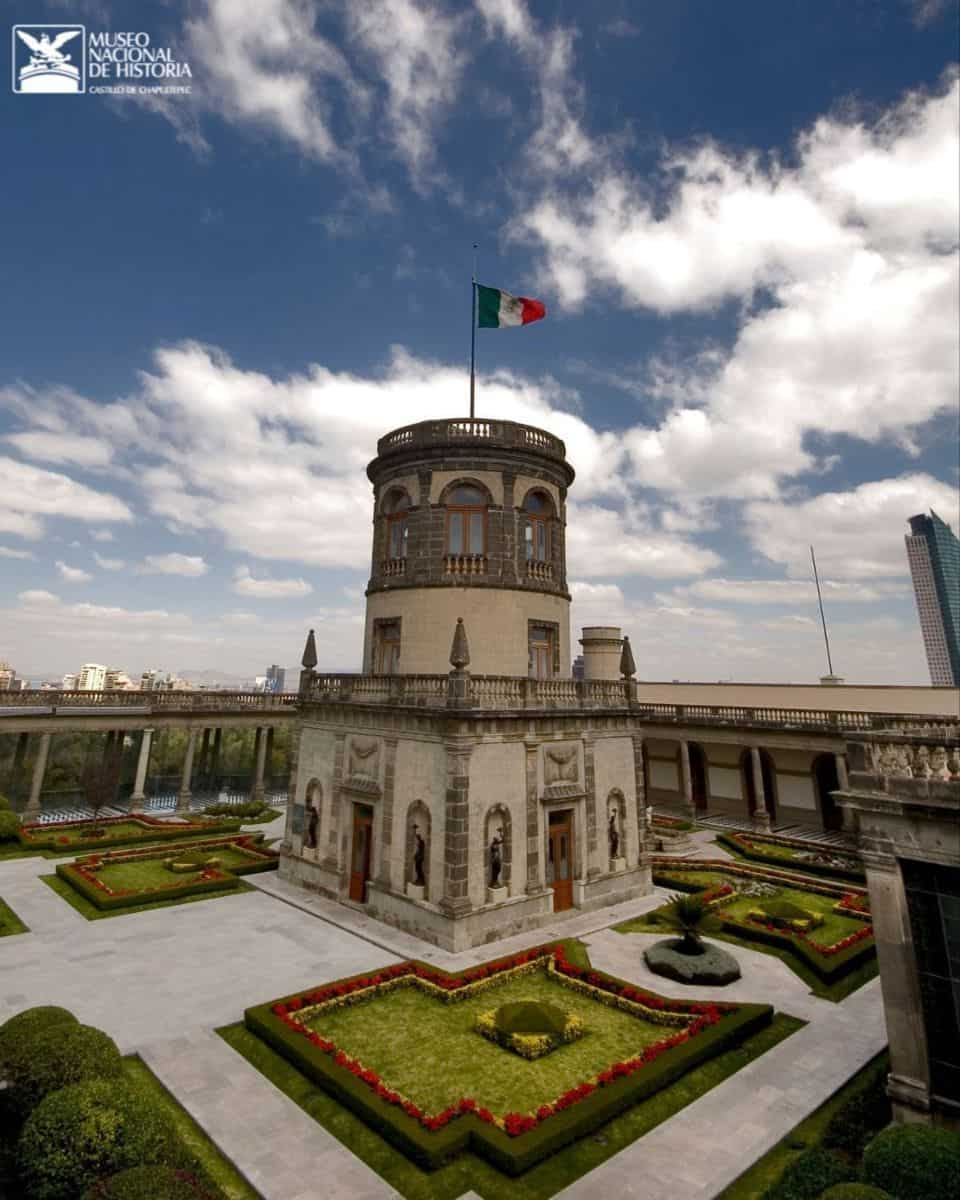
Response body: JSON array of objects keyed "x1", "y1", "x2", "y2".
[{"x1": 7, "y1": 1022, "x2": 124, "y2": 1120}]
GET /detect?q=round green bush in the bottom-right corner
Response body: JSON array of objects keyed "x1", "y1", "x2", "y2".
[{"x1": 863, "y1": 1124, "x2": 960, "y2": 1200}]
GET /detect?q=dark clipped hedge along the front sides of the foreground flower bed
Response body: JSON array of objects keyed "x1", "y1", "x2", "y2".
[{"x1": 244, "y1": 967, "x2": 773, "y2": 1175}]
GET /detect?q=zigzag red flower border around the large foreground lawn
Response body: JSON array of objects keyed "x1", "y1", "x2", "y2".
[{"x1": 270, "y1": 944, "x2": 737, "y2": 1138}]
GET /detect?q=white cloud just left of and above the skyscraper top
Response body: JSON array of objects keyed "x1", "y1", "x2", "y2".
[{"x1": 744, "y1": 474, "x2": 960, "y2": 580}]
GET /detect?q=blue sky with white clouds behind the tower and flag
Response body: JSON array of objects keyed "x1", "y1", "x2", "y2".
[{"x1": 0, "y1": 0, "x2": 958, "y2": 683}]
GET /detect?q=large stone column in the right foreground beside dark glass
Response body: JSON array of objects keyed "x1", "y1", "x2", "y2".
[{"x1": 863, "y1": 851, "x2": 930, "y2": 1121}]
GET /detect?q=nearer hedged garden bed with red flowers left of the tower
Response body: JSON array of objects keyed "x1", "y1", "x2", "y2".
[{"x1": 41, "y1": 834, "x2": 278, "y2": 918}]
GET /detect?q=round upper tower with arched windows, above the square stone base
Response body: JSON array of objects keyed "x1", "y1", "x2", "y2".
[{"x1": 364, "y1": 419, "x2": 574, "y2": 679}]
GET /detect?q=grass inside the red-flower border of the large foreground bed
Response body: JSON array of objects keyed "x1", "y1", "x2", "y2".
[{"x1": 308, "y1": 970, "x2": 673, "y2": 1116}]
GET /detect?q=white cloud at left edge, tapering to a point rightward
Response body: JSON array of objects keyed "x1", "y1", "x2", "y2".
[{"x1": 0, "y1": 456, "x2": 132, "y2": 540}]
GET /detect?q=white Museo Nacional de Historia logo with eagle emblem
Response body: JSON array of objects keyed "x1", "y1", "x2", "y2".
[{"x1": 12, "y1": 25, "x2": 193, "y2": 95}]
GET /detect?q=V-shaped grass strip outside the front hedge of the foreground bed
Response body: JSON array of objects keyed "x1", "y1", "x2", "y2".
[{"x1": 217, "y1": 1012, "x2": 804, "y2": 1200}]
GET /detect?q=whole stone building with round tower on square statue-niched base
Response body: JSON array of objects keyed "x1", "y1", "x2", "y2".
[{"x1": 281, "y1": 420, "x2": 652, "y2": 949}]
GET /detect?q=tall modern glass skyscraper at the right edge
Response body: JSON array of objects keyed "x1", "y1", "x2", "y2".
[{"x1": 906, "y1": 509, "x2": 960, "y2": 688}]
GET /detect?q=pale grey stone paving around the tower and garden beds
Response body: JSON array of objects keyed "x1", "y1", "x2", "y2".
[{"x1": 0, "y1": 827, "x2": 886, "y2": 1200}]
